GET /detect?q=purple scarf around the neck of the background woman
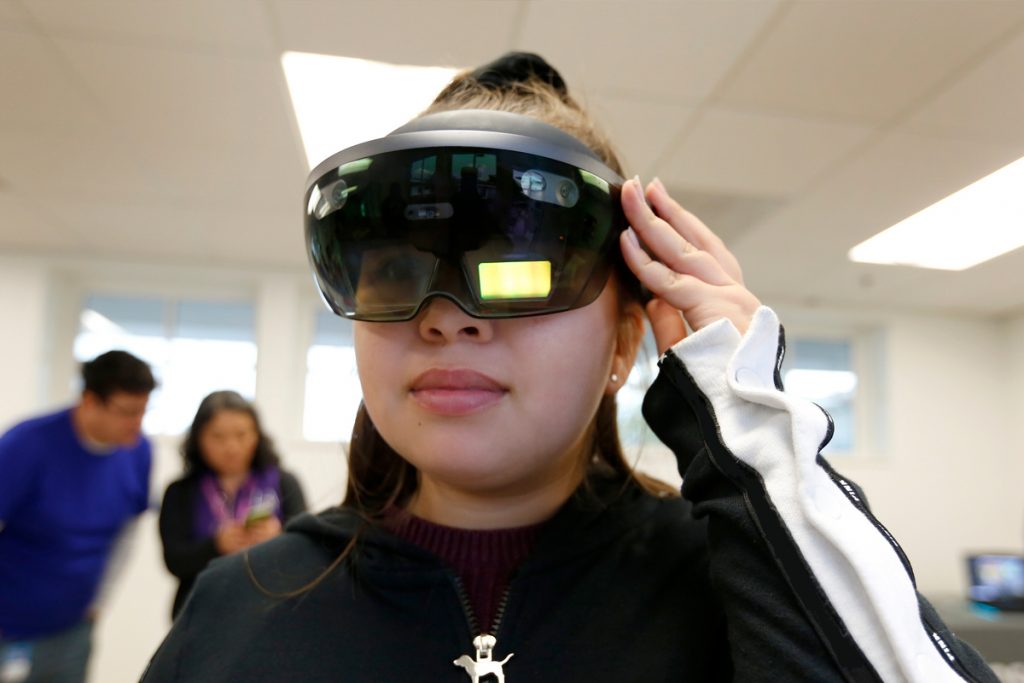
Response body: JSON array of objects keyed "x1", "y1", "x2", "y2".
[{"x1": 193, "y1": 467, "x2": 284, "y2": 539}]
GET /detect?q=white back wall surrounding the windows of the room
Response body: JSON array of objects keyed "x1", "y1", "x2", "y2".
[{"x1": 0, "y1": 255, "x2": 1024, "y2": 681}]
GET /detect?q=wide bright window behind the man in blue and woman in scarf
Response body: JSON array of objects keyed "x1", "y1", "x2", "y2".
[{"x1": 74, "y1": 295, "x2": 256, "y2": 434}]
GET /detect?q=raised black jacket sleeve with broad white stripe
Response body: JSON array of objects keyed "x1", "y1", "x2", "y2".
[{"x1": 643, "y1": 307, "x2": 997, "y2": 683}]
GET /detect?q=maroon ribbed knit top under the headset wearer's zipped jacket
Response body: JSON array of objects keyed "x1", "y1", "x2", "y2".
[{"x1": 385, "y1": 512, "x2": 543, "y2": 631}]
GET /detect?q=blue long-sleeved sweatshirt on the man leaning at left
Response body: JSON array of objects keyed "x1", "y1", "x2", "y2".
[{"x1": 0, "y1": 409, "x2": 153, "y2": 640}]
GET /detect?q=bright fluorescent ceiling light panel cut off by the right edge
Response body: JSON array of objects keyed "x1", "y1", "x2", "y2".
[{"x1": 850, "y1": 157, "x2": 1024, "y2": 270}]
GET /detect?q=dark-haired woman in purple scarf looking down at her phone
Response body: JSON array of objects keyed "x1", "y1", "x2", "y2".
[{"x1": 160, "y1": 391, "x2": 306, "y2": 617}]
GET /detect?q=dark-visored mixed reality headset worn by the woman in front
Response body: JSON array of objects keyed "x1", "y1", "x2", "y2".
[{"x1": 305, "y1": 110, "x2": 626, "y2": 322}]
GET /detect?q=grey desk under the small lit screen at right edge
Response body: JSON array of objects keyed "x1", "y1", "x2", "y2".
[{"x1": 928, "y1": 596, "x2": 1024, "y2": 664}]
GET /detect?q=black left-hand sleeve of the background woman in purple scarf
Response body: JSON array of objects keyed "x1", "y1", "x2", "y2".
[{"x1": 160, "y1": 480, "x2": 220, "y2": 581}]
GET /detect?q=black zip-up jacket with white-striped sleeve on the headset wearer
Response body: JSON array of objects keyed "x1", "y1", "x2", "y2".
[{"x1": 144, "y1": 309, "x2": 996, "y2": 683}]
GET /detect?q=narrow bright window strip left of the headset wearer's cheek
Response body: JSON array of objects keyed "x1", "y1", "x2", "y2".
[{"x1": 302, "y1": 310, "x2": 362, "y2": 441}]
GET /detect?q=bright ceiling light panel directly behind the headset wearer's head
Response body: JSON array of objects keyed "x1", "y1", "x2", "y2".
[{"x1": 281, "y1": 52, "x2": 458, "y2": 168}]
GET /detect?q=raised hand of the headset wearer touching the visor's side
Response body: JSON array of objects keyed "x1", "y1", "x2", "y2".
[{"x1": 620, "y1": 178, "x2": 761, "y2": 353}]
